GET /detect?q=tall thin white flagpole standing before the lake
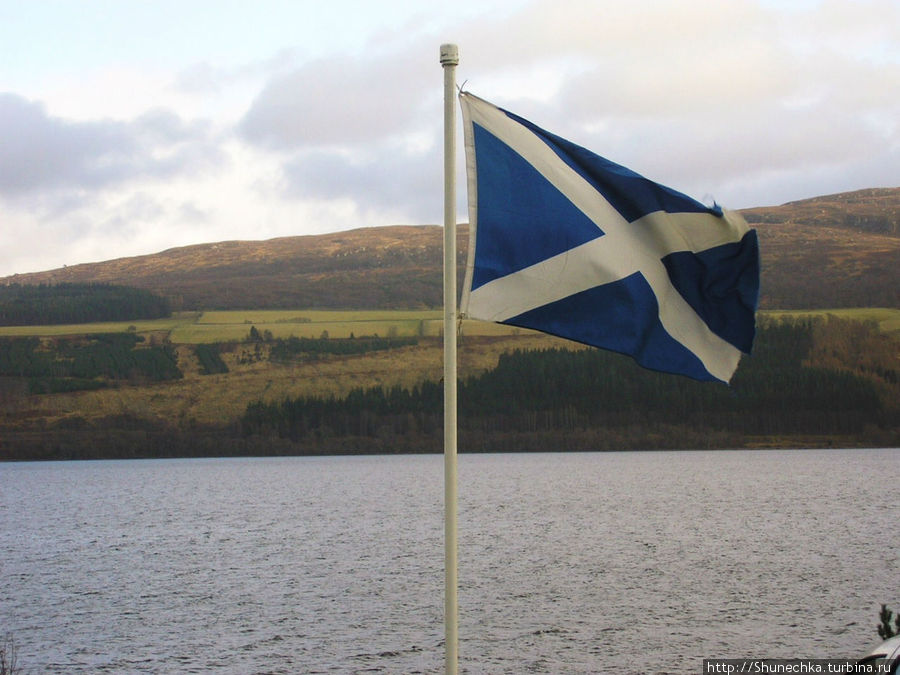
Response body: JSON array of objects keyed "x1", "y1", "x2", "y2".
[{"x1": 441, "y1": 44, "x2": 459, "y2": 675}]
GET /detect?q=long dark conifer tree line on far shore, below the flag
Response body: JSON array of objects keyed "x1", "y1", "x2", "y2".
[{"x1": 240, "y1": 320, "x2": 900, "y2": 451}]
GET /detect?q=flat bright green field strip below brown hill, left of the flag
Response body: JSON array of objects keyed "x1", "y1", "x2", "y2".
[{"x1": 0, "y1": 310, "x2": 528, "y2": 344}]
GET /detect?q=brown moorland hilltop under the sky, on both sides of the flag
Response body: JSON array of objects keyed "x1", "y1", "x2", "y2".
[{"x1": 7, "y1": 188, "x2": 900, "y2": 310}]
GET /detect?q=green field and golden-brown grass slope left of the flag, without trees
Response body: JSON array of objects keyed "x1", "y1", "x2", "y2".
[{"x1": 0, "y1": 310, "x2": 552, "y2": 429}]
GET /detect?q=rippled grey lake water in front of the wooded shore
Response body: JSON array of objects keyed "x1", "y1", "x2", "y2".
[{"x1": 0, "y1": 449, "x2": 900, "y2": 675}]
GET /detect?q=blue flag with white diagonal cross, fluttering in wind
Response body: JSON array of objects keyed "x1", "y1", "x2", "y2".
[{"x1": 460, "y1": 92, "x2": 759, "y2": 382}]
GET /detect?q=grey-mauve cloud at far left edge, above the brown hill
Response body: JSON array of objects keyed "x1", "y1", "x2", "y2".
[{"x1": 0, "y1": 94, "x2": 219, "y2": 197}]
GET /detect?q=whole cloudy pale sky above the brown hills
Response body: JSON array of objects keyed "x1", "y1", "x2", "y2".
[{"x1": 0, "y1": 0, "x2": 900, "y2": 276}]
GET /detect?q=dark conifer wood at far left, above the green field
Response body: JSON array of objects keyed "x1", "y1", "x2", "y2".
[{"x1": 0, "y1": 283, "x2": 171, "y2": 326}]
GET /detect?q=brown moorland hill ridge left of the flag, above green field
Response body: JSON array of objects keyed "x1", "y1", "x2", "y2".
[{"x1": 0, "y1": 226, "x2": 467, "y2": 310}]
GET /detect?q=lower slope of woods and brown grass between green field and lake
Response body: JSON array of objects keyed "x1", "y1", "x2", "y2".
[{"x1": 0, "y1": 310, "x2": 900, "y2": 461}]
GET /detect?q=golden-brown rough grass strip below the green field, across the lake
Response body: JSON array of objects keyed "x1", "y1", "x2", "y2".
[{"x1": 0, "y1": 333, "x2": 564, "y2": 430}]
